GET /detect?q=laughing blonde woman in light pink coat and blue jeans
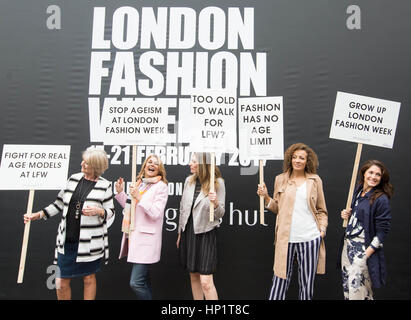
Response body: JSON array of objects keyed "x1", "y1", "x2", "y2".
[{"x1": 115, "y1": 155, "x2": 168, "y2": 300}]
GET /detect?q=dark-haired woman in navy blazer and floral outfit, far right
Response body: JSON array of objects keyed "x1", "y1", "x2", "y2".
[{"x1": 338, "y1": 160, "x2": 393, "y2": 300}]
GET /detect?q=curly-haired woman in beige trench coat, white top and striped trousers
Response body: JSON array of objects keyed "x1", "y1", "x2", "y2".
[{"x1": 257, "y1": 143, "x2": 328, "y2": 300}]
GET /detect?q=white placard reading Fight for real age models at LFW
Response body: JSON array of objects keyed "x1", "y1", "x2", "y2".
[{"x1": 0, "y1": 144, "x2": 70, "y2": 190}]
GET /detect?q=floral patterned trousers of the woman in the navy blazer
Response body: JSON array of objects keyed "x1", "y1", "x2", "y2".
[{"x1": 341, "y1": 232, "x2": 373, "y2": 300}]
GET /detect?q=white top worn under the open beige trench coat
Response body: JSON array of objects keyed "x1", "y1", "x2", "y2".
[{"x1": 288, "y1": 182, "x2": 321, "y2": 243}]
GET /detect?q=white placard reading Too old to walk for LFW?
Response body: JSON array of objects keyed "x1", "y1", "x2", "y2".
[{"x1": 187, "y1": 90, "x2": 237, "y2": 153}]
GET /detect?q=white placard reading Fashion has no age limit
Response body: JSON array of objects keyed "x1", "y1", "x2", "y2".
[{"x1": 238, "y1": 97, "x2": 284, "y2": 160}]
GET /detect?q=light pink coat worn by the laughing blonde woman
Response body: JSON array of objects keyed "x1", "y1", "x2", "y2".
[{"x1": 115, "y1": 181, "x2": 168, "y2": 263}]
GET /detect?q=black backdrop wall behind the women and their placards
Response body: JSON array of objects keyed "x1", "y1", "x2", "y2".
[{"x1": 0, "y1": 0, "x2": 411, "y2": 299}]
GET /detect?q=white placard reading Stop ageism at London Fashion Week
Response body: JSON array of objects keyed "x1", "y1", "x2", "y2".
[{"x1": 101, "y1": 98, "x2": 176, "y2": 145}]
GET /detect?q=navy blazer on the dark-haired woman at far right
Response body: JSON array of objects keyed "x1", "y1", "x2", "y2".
[{"x1": 337, "y1": 185, "x2": 391, "y2": 288}]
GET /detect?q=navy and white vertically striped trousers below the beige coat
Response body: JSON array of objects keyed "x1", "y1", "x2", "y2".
[{"x1": 269, "y1": 237, "x2": 321, "y2": 300}]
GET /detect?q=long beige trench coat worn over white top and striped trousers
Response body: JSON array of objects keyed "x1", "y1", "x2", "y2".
[{"x1": 267, "y1": 172, "x2": 328, "y2": 279}]
